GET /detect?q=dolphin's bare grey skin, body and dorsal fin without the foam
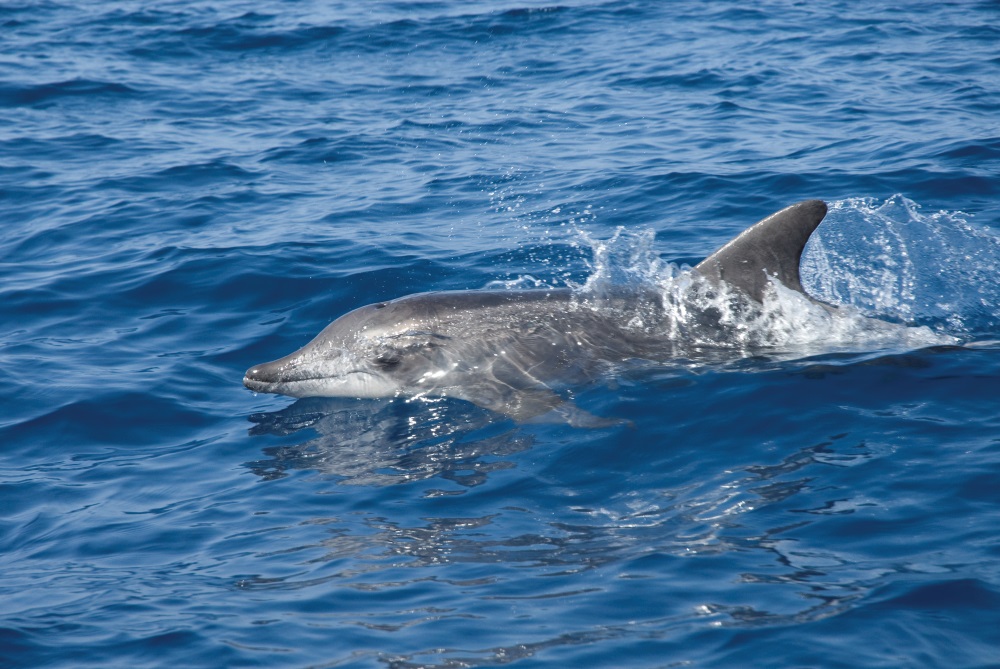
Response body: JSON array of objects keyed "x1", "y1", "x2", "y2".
[{"x1": 243, "y1": 200, "x2": 827, "y2": 425}]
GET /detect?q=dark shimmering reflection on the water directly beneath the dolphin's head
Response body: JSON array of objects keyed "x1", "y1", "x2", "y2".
[{"x1": 248, "y1": 398, "x2": 533, "y2": 487}]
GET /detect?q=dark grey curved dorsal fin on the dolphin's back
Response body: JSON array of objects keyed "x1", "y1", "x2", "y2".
[{"x1": 695, "y1": 200, "x2": 826, "y2": 302}]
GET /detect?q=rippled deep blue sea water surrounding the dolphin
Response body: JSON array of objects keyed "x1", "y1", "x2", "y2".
[{"x1": 0, "y1": 0, "x2": 1000, "y2": 668}]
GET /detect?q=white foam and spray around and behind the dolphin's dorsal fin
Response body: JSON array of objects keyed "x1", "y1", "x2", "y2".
[{"x1": 574, "y1": 196, "x2": 984, "y2": 357}]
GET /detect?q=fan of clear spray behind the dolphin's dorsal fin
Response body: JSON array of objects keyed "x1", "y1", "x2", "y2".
[{"x1": 801, "y1": 195, "x2": 1000, "y2": 339}]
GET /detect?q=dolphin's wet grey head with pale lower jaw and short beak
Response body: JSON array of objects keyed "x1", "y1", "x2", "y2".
[{"x1": 243, "y1": 300, "x2": 446, "y2": 398}]
